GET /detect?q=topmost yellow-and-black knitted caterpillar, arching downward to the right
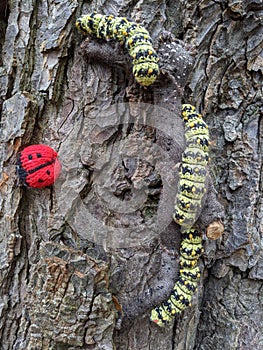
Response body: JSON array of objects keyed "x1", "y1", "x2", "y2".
[{"x1": 76, "y1": 12, "x2": 159, "y2": 86}]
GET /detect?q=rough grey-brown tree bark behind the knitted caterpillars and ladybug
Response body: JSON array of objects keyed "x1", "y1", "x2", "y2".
[{"x1": 0, "y1": 0, "x2": 263, "y2": 350}]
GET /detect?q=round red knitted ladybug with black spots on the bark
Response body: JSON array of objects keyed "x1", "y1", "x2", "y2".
[{"x1": 17, "y1": 145, "x2": 61, "y2": 188}]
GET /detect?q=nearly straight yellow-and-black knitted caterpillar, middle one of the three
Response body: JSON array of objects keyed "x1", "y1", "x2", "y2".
[{"x1": 173, "y1": 104, "x2": 209, "y2": 229}]
